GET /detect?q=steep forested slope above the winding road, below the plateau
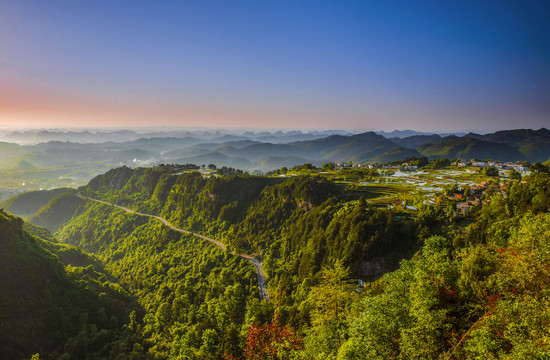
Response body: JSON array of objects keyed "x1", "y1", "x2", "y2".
[{"x1": 76, "y1": 168, "x2": 414, "y2": 291}]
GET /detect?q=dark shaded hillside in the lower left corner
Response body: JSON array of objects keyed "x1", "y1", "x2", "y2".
[{"x1": 0, "y1": 211, "x2": 137, "y2": 359}]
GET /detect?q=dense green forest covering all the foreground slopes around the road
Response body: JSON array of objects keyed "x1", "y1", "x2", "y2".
[{"x1": 0, "y1": 164, "x2": 550, "y2": 359}]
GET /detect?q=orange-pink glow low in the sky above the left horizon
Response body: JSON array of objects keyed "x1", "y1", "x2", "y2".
[{"x1": 0, "y1": 78, "x2": 376, "y2": 128}]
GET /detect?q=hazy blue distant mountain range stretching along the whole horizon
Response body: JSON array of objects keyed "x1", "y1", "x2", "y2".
[{"x1": 0, "y1": 128, "x2": 550, "y2": 185}]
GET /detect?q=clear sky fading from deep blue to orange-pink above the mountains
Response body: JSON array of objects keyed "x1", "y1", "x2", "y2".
[{"x1": 0, "y1": 0, "x2": 550, "y2": 131}]
